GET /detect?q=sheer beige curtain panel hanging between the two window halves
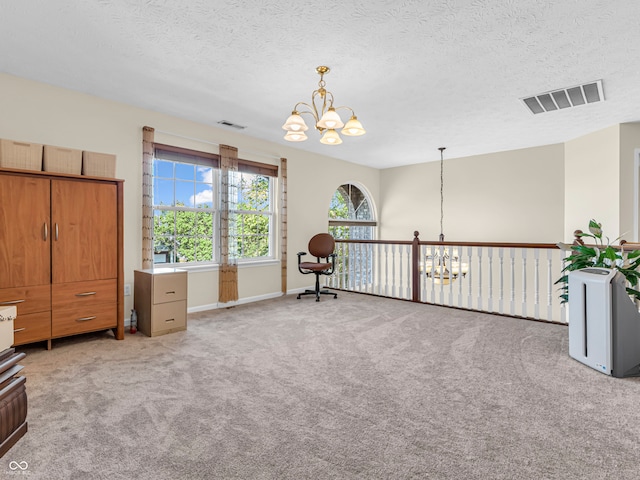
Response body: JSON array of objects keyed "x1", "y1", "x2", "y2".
[{"x1": 218, "y1": 145, "x2": 238, "y2": 303}]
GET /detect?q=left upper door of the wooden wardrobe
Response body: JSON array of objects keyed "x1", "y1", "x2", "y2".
[{"x1": 0, "y1": 174, "x2": 51, "y2": 289}]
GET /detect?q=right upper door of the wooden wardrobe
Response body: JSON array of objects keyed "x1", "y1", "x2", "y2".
[{"x1": 51, "y1": 179, "x2": 118, "y2": 284}]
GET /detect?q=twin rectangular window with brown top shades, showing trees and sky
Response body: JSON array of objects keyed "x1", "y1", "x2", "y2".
[{"x1": 152, "y1": 144, "x2": 277, "y2": 264}]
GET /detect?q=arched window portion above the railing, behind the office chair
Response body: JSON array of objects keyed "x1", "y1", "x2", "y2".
[{"x1": 329, "y1": 183, "x2": 377, "y2": 240}]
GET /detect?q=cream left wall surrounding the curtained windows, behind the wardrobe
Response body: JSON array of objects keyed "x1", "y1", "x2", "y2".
[{"x1": 0, "y1": 74, "x2": 379, "y2": 315}]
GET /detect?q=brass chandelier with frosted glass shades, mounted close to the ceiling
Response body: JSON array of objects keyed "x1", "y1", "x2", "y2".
[{"x1": 282, "y1": 66, "x2": 365, "y2": 145}]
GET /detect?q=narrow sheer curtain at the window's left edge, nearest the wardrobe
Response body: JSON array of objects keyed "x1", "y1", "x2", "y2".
[{"x1": 142, "y1": 127, "x2": 155, "y2": 269}]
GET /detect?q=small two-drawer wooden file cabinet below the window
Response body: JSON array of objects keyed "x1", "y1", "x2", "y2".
[{"x1": 133, "y1": 268, "x2": 187, "y2": 337}]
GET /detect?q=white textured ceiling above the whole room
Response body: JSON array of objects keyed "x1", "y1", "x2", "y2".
[{"x1": 0, "y1": 0, "x2": 640, "y2": 168}]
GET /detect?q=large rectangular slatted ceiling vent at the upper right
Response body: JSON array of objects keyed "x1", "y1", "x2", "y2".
[{"x1": 521, "y1": 80, "x2": 604, "y2": 115}]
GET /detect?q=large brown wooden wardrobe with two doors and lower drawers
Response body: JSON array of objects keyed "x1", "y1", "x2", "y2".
[{"x1": 0, "y1": 169, "x2": 124, "y2": 348}]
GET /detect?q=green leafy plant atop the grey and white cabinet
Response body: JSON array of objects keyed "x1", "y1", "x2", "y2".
[{"x1": 555, "y1": 219, "x2": 640, "y2": 303}]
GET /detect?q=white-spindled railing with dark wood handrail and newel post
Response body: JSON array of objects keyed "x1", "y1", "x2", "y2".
[{"x1": 327, "y1": 232, "x2": 567, "y2": 323}]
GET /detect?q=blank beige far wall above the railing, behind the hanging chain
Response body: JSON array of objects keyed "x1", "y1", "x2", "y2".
[{"x1": 380, "y1": 144, "x2": 564, "y2": 243}]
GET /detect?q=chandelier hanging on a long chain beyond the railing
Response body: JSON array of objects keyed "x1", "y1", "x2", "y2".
[{"x1": 424, "y1": 147, "x2": 469, "y2": 285}]
